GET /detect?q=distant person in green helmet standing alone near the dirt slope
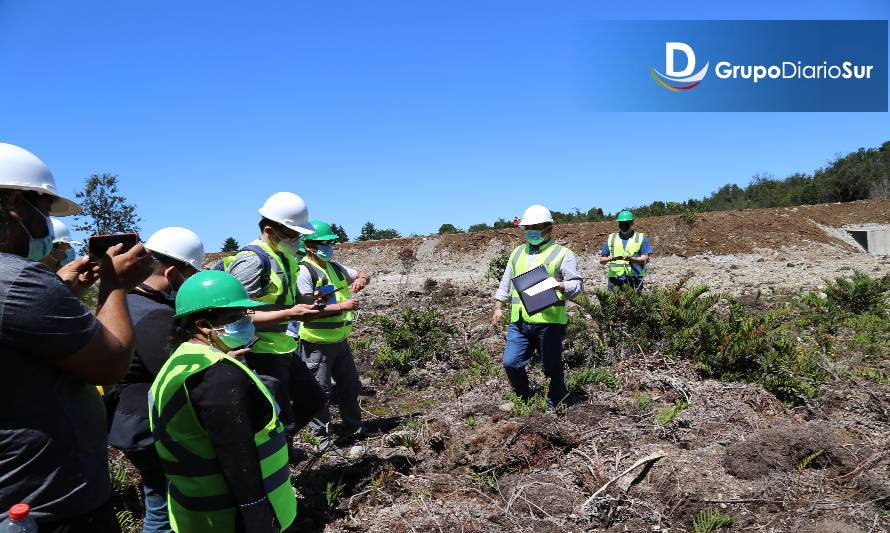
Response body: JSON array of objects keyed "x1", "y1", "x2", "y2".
[{"x1": 597, "y1": 209, "x2": 652, "y2": 291}]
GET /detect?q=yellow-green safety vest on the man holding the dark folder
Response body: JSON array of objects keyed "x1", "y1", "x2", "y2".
[{"x1": 510, "y1": 241, "x2": 570, "y2": 324}]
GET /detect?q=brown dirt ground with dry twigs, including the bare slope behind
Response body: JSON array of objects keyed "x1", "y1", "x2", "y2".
[{"x1": 201, "y1": 200, "x2": 890, "y2": 533}]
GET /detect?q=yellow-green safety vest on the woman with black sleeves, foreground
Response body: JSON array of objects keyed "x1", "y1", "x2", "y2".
[{"x1": 148, "y1": 343, "x2": 297, "y2": 533}]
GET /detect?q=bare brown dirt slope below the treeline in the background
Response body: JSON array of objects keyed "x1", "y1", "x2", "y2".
[{"x1": 337, "y1": 199, "x2": 890, "y2": 294}]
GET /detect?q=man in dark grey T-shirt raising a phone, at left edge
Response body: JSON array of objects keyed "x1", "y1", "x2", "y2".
[{"x1": 0, "y1": 143, "x2": 151, "y2": 533}]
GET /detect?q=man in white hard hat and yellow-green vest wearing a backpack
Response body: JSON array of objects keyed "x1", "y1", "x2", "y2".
[{"x1": 217, "y1": 192, "x2": 325, "y2": 462}]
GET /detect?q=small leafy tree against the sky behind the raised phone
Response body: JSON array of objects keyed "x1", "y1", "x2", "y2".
[{"x1": 74, "y1": 173, "x2": 141, "y2": 243}]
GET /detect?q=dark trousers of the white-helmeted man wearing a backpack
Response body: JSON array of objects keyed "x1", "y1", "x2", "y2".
[{"x1": 244, "y1": 353, "x2": 326, "y2": 437}]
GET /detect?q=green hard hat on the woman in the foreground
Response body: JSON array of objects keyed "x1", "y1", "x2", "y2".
[{"x1": 174, "y1": 270, "x2": 263, "y2": 318}]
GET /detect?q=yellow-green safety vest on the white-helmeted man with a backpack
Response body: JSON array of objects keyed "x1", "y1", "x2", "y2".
[{"x1": 223, "y1": 239, "x2": 299, "y2": 355}]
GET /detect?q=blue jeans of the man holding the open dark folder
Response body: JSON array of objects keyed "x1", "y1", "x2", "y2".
[{"x1": 504, "y1": 321, "x2": 566, "y2": 407}]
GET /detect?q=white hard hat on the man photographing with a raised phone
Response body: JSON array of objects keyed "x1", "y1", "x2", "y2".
[{"x1": 0, "y1": 143, "x2": 82, "y2": 217}]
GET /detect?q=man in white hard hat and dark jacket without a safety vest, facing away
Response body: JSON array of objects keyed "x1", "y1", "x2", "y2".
[{"x1": 106, "y1": 227, "x2": 204, "y2": 532}]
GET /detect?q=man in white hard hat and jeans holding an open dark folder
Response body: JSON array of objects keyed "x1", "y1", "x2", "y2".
[{"x1": 491, "y1": 205, "x2": 583, "y2": 407}]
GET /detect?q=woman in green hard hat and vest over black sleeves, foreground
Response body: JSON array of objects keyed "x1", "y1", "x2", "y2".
[{"x1": 148, "y1": 270, "x2": 297, "y2": 533}]
